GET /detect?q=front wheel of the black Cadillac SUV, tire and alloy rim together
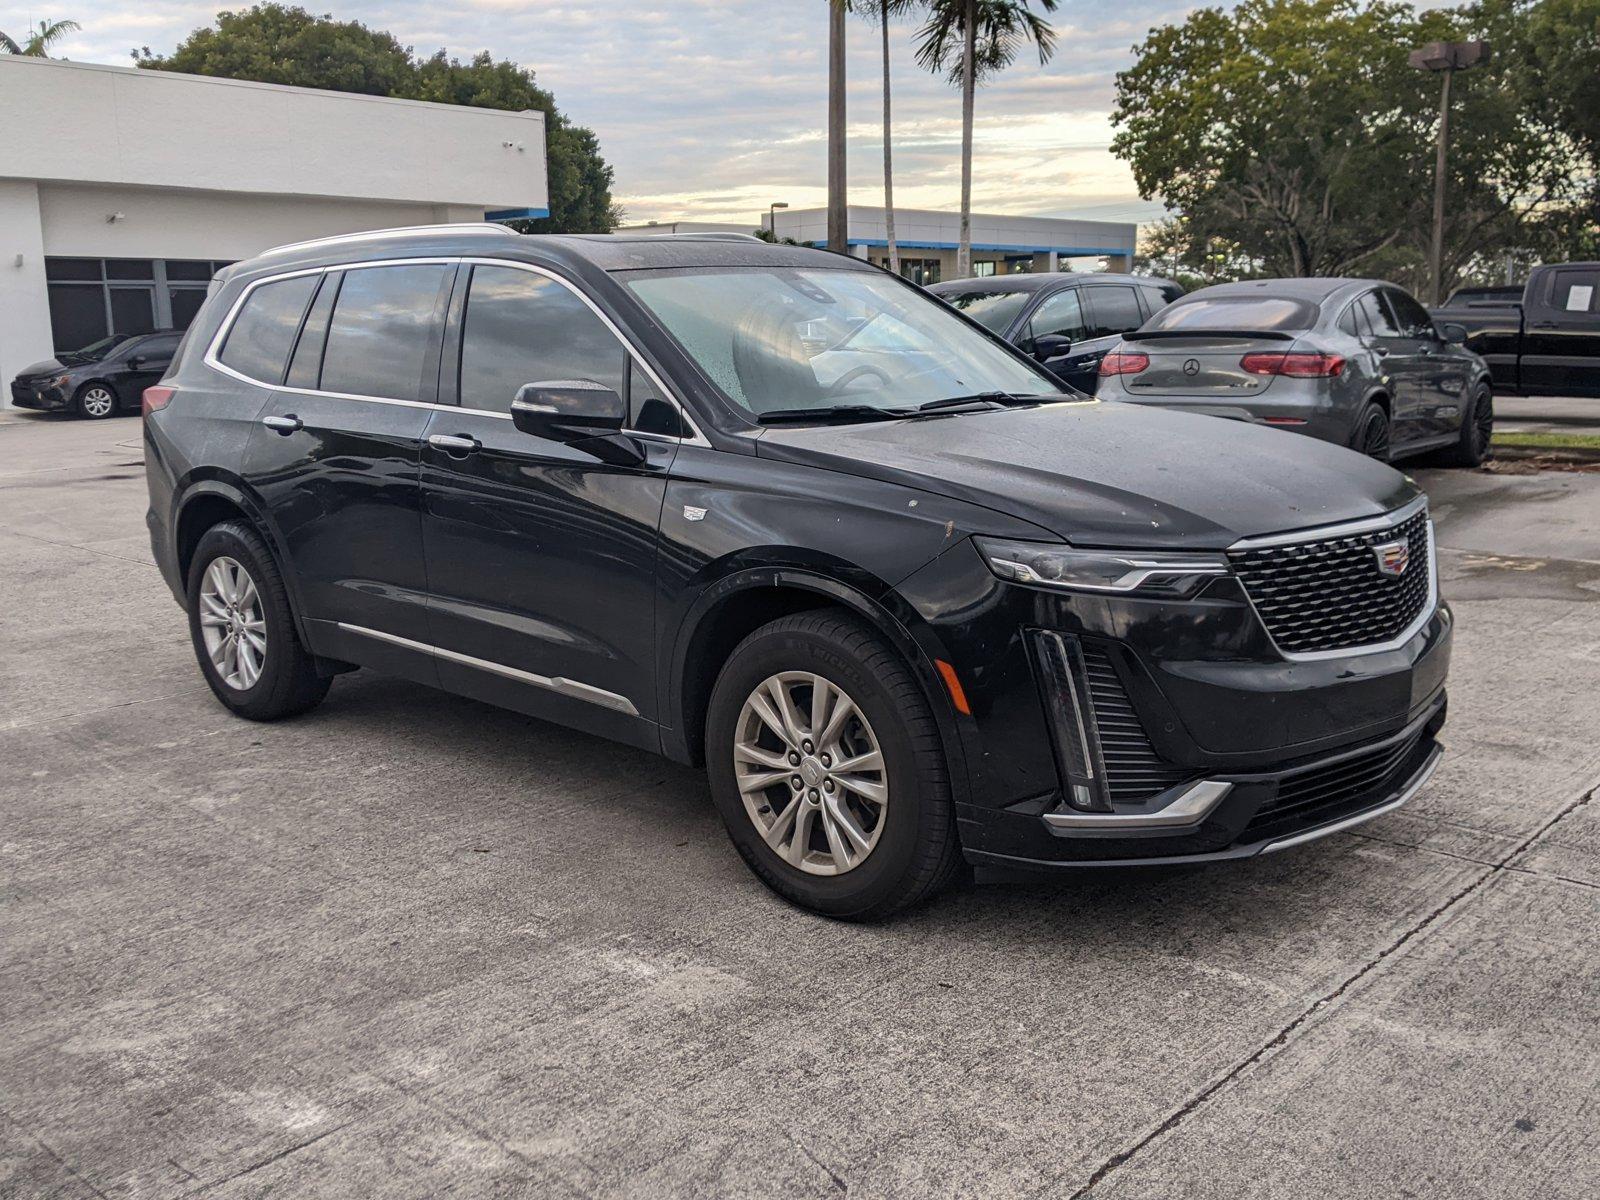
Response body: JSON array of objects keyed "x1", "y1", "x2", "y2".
[{"x1": 706, "y1": 610, "x2": 962, "y2": 920}]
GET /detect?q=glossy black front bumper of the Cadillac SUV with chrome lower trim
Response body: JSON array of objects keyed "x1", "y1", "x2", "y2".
[{"x1": 898, "y1": 534, "x2": 1453, "y2": 869}]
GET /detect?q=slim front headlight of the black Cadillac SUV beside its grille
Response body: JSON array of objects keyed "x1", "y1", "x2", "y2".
[{"x1": 973, "y1": 538, "x2": 1227, "y2": 597}]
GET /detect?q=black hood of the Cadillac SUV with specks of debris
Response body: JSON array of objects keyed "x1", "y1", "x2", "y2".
[{"x1": 757, "y1": 400, "x2": 1418, "y2": 549}]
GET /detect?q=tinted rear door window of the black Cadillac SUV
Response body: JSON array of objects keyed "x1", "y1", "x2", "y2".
[{"x1": 322, "y1": 262, "x2": 450, "y2": 400}]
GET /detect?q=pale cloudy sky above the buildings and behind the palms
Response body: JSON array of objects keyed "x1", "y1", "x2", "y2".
[{"x1": 0, "y1": 0, "x2": 1192, "y2": 221}]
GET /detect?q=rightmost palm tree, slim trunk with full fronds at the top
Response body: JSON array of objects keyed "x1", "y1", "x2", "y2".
[{"x1": 917, "y1": 0, "x2": 1058, "y2": 278}]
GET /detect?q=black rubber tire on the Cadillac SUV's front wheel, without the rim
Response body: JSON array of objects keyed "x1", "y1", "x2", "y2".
[{"x1": 706, "y1": 610, "x2": 962, "y2": 920}]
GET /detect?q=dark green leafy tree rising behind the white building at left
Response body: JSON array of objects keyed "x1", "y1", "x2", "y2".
[{"x1": 134, "y1": 3, "x2": 616, "y2": 234}]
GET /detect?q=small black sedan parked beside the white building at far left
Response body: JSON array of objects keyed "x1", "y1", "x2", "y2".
[{"x1": 11, "y1": 330, "x2": 182, "y2": 421}]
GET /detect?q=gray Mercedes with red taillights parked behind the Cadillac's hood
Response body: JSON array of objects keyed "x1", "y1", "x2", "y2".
[{"x1": 1096, "y1": 278, "x2": 1494, "y2": 466}]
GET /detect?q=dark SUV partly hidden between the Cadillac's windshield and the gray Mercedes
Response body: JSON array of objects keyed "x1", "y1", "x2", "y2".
[{"x1": 928, "y1": 272, "x2": 1184, "y2": 395}]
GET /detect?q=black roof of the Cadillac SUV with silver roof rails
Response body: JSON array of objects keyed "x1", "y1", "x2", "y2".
[{"x1": 218, "y1": 222, "x2": 875, "y2": 280}]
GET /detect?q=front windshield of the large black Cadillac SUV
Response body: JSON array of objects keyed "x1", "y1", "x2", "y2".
[{"x1": 629, "y1": 267, "x2": 1075, "y2": 416}]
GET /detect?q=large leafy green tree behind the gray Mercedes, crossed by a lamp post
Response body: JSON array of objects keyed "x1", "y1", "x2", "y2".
[{"x1": 1112, "y1": 0, "x2": 1573, "y2": 289}]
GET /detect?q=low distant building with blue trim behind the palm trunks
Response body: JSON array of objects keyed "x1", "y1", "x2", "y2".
[{"x1": 616, "y1": 205, "x2": 1139, "y2": 283}]
